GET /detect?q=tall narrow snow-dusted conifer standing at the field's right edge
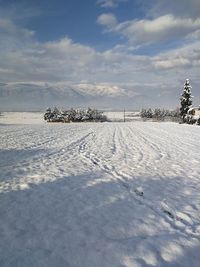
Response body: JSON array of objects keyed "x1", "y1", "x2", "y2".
[{"x1": 180, "y1": 79, "x2": 192, "y2": 122}]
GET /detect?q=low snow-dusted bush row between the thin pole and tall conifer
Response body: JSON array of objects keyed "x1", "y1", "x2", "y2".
[{"x1": 140, "y1": 108, "x2": 180, "y2": 121}]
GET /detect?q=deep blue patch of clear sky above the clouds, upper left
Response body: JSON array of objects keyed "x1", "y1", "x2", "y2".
[{"x1": 1, "y1": 0, "x2": 143, "y2": 50}]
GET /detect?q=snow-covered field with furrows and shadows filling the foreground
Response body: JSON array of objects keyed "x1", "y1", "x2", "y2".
[{"x1": 0, "y1": 113, "x2": 200, "y2": 267}]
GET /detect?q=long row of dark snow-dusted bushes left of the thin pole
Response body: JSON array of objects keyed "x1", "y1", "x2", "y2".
[{"x1": 44, "y1": 108, "x2": 107, "y2": 122}]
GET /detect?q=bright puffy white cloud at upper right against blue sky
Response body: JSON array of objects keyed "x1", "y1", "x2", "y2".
[{"x1": 98, "y1": 14, "x2": 200, "y2": 46}]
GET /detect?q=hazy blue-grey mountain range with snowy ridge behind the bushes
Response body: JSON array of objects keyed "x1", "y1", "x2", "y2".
[{"x1": 0, "y1": 81, "x2": 181, "y2": 111}]
